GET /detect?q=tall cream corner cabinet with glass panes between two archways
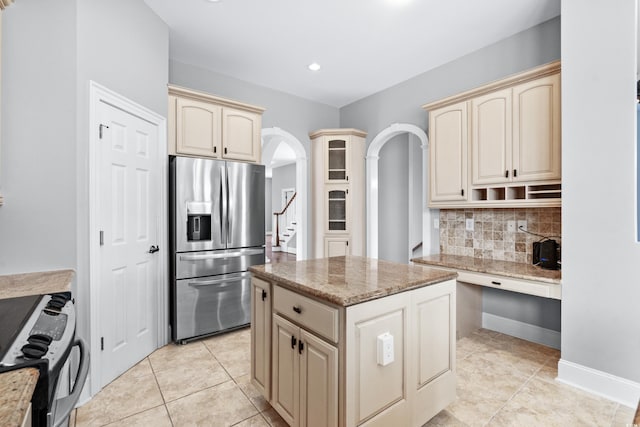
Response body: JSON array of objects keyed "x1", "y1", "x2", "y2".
[{"x1": 309, "y1": 129, "x2": 367, "y2": 258}]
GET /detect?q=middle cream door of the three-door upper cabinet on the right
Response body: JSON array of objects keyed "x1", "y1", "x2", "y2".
[{"x1": 471, "y1": 89, "x2": 512, "y2": 184}]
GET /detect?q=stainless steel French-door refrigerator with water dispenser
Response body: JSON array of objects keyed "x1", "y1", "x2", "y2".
[{"x1": 169, "y1": 156, "x2": 265, "y2": 343}]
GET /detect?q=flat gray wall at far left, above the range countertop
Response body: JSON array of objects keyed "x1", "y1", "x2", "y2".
[{"x1": 0, "y1": 0, "x2": 77, "y2": 274}]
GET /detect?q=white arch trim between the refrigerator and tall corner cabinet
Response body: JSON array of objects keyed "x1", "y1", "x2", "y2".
[{"x1": 262, "y1": 127, "x2": 309, "y2": 260}]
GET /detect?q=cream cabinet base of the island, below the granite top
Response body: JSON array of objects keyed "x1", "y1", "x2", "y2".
[{"x1": 251, "y1": 279, "x2": 456, "y2": 427}]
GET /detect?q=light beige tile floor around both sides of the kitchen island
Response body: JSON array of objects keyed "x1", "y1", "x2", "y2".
[{"x1": 71, "y1": 328, "x2": 634, "y2": 427}]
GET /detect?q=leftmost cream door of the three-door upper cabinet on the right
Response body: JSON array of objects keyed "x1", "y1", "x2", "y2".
[{"x1": 429, "y1": 101, "x2": 469, "y2": 202}]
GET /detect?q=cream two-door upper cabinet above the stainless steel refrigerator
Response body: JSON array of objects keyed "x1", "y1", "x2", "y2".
[{"x1": 168, "y1": 86, "x2": 264, "y2": 163}]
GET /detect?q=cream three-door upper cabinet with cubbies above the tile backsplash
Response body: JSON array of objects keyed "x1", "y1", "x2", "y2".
[{"x1": 423, "y1": 61, "x2": 562, "y2": 208}]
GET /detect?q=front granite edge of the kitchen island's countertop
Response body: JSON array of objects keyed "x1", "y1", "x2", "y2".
[{"x1": 249, "y1": 267, "x2": 458, "y2": 307}]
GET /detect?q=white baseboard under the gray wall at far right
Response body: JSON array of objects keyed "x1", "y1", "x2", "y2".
[{"x1": 556, "y1": 359, "x2": 640, "y2": 408}]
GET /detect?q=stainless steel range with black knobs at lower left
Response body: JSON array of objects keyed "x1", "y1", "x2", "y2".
[{"x1": 0, "y1": 292, "x2": 89, "y2": 427}]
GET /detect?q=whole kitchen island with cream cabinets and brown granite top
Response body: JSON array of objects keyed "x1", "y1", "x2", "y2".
[{"x1": 250, "y1": 256, "x2": 456, "y2": 426}]
